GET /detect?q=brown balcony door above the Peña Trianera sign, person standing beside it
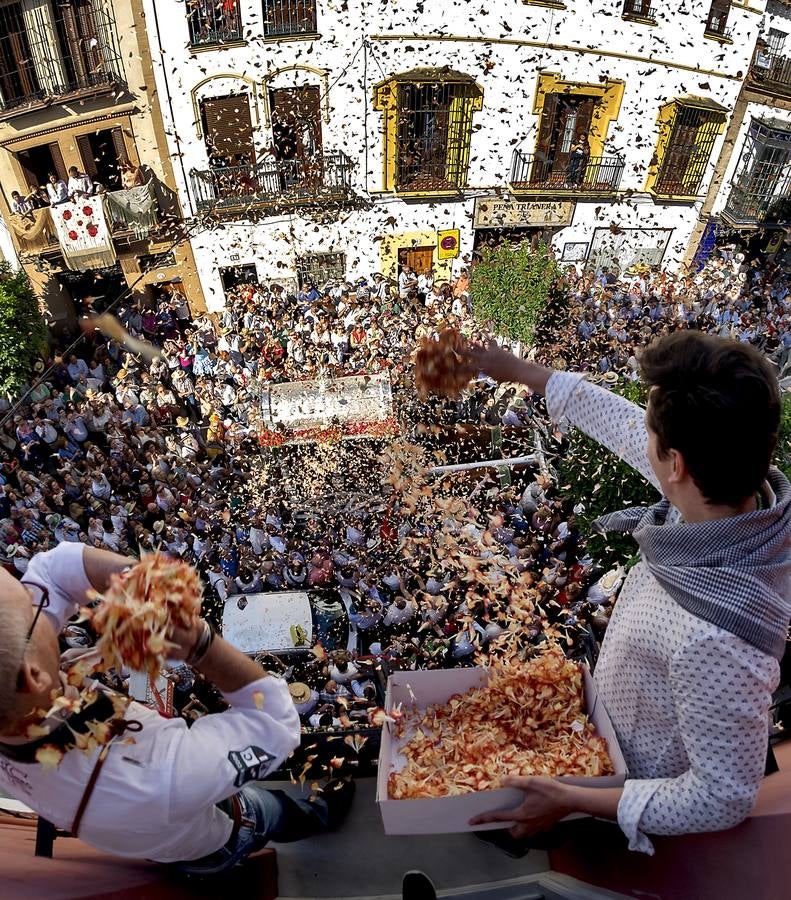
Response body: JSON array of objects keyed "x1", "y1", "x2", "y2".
[{"x1": 530, "y1": 94, "x2": 597, "y2": 183}]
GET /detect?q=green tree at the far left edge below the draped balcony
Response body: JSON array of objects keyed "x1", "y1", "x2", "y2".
[{"x1": 0, "y1": 262, "x2": 47, "y2": 396}]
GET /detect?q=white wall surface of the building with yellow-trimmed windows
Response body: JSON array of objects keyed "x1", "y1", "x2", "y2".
[{"x1": 144, "y1": 0, "x2": 765, "y2": 307}]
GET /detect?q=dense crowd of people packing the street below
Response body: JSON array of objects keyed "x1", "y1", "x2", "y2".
[{"x1": 0, "y1": 241, "x2": 791, "y2": 729}]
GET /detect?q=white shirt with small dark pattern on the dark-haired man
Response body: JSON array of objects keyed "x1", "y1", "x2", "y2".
[{"x1": 546, "y1": 372, "x2": 780, "y2": 853}]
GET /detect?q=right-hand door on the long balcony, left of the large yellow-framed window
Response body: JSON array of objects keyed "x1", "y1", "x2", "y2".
[{"x1": 269, "y1": 85, "x2": 321, "y2": 185}]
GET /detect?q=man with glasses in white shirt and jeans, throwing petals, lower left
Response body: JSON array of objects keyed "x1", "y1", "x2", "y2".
[{"x1": 0, "y1": 543, "x2": 353, "y2": 874}]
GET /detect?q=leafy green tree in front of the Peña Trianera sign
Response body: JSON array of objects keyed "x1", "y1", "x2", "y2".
[{"x1": 471, "y1": 241, "x2": 560, "y2": 343}]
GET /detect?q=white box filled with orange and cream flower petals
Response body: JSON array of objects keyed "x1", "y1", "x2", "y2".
[{"x1": 377, "y1": 647, "x2": 626, "y2": 834}]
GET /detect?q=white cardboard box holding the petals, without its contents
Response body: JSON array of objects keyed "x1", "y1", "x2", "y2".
[{"x1": 376, "y1": 668, "x2": 626, "y2": 834}]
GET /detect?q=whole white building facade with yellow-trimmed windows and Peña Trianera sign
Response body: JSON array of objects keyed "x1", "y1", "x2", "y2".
[{"x1": 144, "y1": 0, "x2": 765, "y2": 309}]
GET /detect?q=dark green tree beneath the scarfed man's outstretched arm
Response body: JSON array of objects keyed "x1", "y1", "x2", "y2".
[{"x1": 559, "y1": 380, "x2": 659, "y2": 568}]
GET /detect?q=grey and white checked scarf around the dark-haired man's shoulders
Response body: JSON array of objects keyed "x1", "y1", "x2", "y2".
[{"x1": 593, "y1": 468, "x2": 791, "y2": 659}]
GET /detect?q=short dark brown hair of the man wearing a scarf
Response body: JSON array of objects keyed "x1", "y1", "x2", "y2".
[{"x1": 640, "y1": 331, "x2": 780, "y2": 506}]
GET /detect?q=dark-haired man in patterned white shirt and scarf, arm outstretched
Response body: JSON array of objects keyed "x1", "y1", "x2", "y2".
[{"x1": 469, "y1": 331, "x2": 791, "y2": 853}]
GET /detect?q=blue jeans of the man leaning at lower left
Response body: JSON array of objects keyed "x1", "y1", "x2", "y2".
[{"x1": 176, "y1": 781, "x2": 328, "y2": 875}]
